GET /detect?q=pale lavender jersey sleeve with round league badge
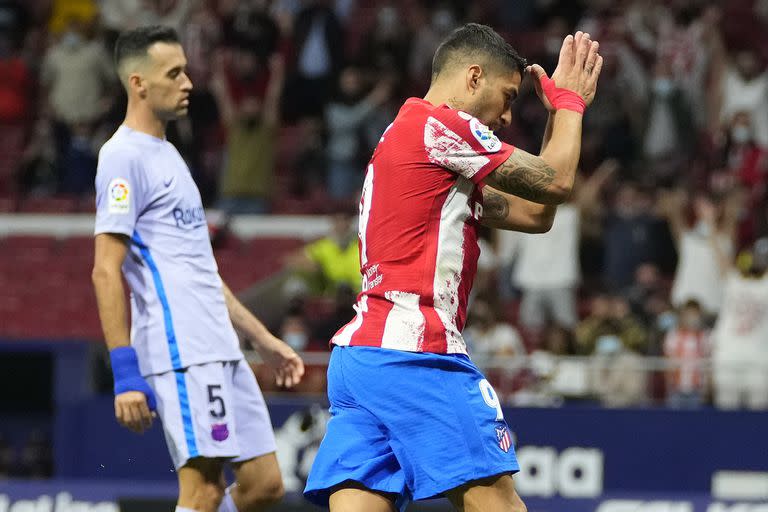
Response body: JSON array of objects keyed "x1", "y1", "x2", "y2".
[{"x1": 94, "y1": 150, "x2": 147, "y2": 236}]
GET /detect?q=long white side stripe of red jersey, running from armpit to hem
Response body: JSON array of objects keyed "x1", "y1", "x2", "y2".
[{"x1": 433, "y1": 176, "x2": 475, "y2": 354}]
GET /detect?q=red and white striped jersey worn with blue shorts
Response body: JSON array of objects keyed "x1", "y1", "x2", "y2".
[{"x1": 331, "y1": 98, "x2": 514, "y2": 354}]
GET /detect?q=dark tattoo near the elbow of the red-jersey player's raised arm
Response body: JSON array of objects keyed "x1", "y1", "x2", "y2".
[{"x1": 493, "y1": 151, "x2": 557, "y2": 201}]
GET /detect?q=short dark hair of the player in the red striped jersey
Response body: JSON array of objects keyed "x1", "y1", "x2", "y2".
[{"x1": 432, "y1": 23, "x2": 527, "y2": 81}]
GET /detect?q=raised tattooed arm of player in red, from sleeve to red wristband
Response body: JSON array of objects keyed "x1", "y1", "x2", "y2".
[{"x1": 484, "y1": 110, "x2": 581, "y2": 204}]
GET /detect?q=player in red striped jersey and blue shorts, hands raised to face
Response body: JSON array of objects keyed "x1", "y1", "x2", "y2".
[{"x1": 305, "y1": 23, "x2": 602, "y2": 512}]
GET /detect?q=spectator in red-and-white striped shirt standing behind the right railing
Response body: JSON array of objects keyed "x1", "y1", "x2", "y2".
[{"x1": 664, "y1": 300, "x2": 710, "y2": 408}]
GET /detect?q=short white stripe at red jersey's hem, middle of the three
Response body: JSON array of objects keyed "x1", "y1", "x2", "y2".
[{"x1": 381, "y1": 290, "x2": 427, "y2": 352}]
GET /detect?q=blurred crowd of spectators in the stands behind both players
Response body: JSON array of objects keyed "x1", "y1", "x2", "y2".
[{"x1": 0, "y1": 0, "x2": 768, "y2": 408}]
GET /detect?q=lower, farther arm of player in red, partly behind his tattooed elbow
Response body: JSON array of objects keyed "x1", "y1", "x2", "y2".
[{"x1": 480, "y1": 185, "x2": 557, "y2": 233}]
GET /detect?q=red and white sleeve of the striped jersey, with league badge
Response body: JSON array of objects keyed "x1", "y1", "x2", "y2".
[{"x1": 424, "y1": 108, "x2": 515, "y2": 183}]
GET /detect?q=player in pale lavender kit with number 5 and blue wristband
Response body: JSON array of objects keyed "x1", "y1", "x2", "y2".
[{"x1": 93, "y1": 26, "x2": 304, "y2": 512}]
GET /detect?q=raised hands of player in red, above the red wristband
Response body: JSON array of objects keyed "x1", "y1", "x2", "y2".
[{"x1": 528, "y1": 31, "x2": 603, "y2": 110}]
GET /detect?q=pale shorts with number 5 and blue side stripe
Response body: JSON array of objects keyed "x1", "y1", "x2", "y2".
[{"x1": 147, "y1": 359, "x2": 276, "y2": 469}]
